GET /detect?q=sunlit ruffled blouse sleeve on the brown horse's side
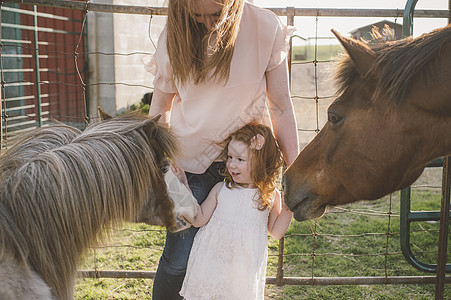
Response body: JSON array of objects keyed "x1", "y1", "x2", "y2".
[{"x1": 266, "y1": 20, "x2": 296, "y2": 71}]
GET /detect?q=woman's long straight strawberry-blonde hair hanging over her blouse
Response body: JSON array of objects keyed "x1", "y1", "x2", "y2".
[{"x1": 166, "y1": 0, "x2": 245, "y2": 84}]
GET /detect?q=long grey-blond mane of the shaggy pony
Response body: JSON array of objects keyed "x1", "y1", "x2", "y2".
[{"x1": 0, "y1": 117, "x2": 177, "y2": 298}]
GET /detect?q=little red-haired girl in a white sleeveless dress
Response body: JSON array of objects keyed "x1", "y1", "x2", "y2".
[{"x1": 180, "y1": 123, "x2": 293, "y2": 300}]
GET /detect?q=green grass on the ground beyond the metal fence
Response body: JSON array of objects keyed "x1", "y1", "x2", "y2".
[{"x1": 75, "y1": 191, "x2": 451, "y2": 299}]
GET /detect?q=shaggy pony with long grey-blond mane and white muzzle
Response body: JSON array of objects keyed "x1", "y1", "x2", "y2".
[{"x1": 0, "y1": 114, "x2": 197, "y2": 299}]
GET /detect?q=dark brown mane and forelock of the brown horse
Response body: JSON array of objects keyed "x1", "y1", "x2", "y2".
[{"x1": 335, "y1": 25, "x2": 451, "y2": 104}]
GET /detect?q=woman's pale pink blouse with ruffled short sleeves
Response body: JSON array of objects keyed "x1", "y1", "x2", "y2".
[{"x1": 145, "y1": 3, "x2": 294, "y2": 173}]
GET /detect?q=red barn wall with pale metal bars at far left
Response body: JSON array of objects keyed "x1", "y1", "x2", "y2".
[{"x1": 0, "y1": 3, "x2": 88, "y2": 148}]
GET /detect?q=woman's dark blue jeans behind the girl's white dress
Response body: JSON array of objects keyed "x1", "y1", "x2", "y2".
[{"x1": 152, "y1": 162, "x2": 225, "y2": 300}]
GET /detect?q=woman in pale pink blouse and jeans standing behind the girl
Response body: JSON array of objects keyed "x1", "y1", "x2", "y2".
[{"x1": 147, "y1": 0, "x2": 298, "y2": 300}]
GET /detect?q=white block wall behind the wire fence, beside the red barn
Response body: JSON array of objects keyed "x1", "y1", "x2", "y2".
[{"x1": 88, "y1": 0, "x2": 166, "y2": 116}]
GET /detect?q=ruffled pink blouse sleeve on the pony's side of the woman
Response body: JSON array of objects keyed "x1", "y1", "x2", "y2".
[{"x1": 141, "y1": 30, "x2": 177, "y2": 94}]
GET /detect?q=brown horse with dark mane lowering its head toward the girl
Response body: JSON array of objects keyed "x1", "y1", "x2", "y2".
[{"x1": 284, "y1": 26, "x2": 451, "y2": 221}]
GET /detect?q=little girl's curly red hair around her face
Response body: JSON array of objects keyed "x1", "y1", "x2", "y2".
[{"x1": 221, "y1": 122, "x2": 283, "y2": 210}]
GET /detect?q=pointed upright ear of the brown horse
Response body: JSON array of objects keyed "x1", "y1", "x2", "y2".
[{"x1": 332, "y1": 29, "x2": 376, "y2": 76}]
